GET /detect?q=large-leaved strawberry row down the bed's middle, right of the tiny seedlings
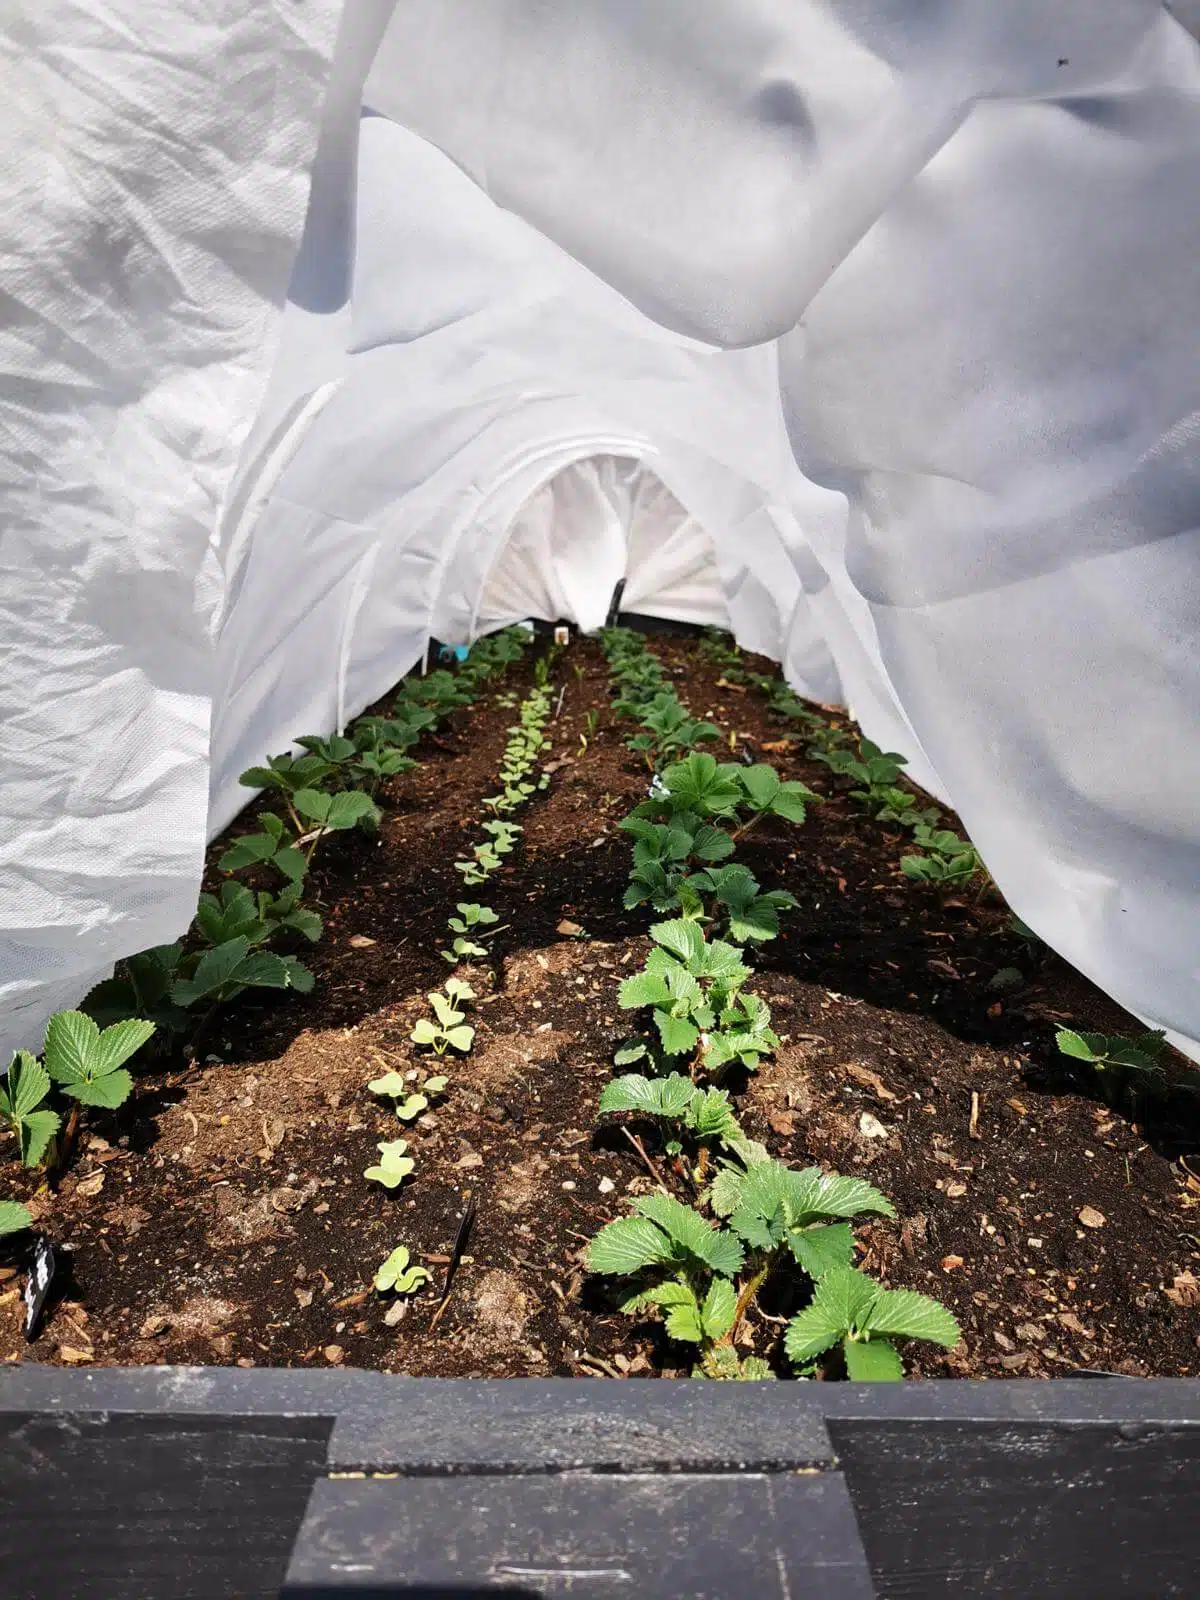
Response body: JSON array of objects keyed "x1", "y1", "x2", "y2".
[{"x1": 587, "y1": 629, "x2": 960, "y2": 1379}]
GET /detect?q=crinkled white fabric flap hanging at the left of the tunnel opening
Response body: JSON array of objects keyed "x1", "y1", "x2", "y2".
[{"x1": 0, "y1": 0, "x2": 338, "y2": 1059}]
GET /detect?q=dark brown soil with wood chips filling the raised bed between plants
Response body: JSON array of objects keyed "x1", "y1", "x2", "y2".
[{"x1": 0, "y1": 640, "x2": 1200, "y2": 1378}]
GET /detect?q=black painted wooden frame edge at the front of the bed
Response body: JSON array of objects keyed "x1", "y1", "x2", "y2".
[{"x1": 0, "y1": 1365, "x2": 1200, "y2": 1600}]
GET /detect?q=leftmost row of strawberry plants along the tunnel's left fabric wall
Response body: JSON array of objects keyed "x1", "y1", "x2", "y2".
[{"x1": 0, "y1": 629, "x2": 530, "y2": 1235}]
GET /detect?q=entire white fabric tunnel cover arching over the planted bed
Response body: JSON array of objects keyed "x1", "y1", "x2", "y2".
[{"x1": 0, "y1": 0, "x2": 1200, "y2": 1048}]
